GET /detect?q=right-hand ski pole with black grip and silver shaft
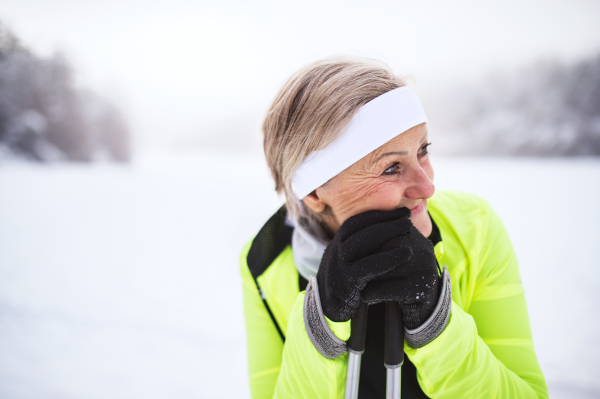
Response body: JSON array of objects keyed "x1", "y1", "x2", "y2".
[{"x1": 383, "y1": 302, "x2": 404, "y2": 399}]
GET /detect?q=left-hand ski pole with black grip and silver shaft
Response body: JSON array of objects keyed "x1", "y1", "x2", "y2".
[{"x1": 344, "y1": 302, "x2": 368, "y2": 399}]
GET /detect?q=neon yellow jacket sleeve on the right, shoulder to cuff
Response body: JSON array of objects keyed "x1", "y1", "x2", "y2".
[{"x1": 405, "y1": 201, "x2": 548, "y2": 399}]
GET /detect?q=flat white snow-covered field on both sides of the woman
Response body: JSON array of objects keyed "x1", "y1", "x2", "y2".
[{"x1": 0, "y1": 153, "x2": 600, "y2": 399}]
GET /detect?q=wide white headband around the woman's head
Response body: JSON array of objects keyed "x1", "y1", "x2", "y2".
[{"x1": 292, "y1": 86, "x2": 427, "y2": 199}]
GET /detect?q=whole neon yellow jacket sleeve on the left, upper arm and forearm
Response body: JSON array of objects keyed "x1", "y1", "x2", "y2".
[{"x1": 240, "y1": 241, "x2": 350, "y2": 399}]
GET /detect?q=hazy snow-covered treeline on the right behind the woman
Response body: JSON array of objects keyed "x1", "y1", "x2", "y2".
[{"x1": 444, "y1": 55, "x2": 600, "y2": 156}]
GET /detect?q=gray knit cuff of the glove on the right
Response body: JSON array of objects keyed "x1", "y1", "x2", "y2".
[{"x1": 404, "y1": 266, "x2": 452, "y2": 349}]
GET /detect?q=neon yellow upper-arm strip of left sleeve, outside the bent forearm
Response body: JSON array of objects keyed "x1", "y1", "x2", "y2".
[{"x1": 240, "y1": 243, "x2": 283, "y2": 399}]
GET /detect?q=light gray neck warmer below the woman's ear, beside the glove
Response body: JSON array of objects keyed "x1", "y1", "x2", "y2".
[{"x1": 292, "y1": 205, "x2": 330, "y2": 280}]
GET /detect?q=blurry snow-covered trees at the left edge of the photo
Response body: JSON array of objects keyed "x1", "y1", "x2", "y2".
[{"x1": 0, "y1": 23, "x2": 131, "y2": 162}]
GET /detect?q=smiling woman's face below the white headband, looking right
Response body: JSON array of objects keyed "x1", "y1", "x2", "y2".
[{"x1": 303, "y1": 124, "x2": 435, "y2": 237}]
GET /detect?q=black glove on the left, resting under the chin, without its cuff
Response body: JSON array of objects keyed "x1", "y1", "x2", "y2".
[{"x1": 317, "y1": 208, "x2": 414, "y2": 322}]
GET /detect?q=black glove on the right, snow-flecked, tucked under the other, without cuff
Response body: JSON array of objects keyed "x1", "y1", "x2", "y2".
[{"x1": 361, "y1": 223, "x2": 442, "y2": 329}]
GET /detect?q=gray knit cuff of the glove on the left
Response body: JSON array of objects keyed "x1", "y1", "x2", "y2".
[{"x1": 304, "y1": 276, "x2": 347, "y2": 359}]
